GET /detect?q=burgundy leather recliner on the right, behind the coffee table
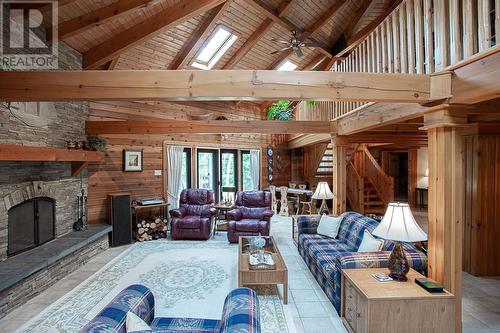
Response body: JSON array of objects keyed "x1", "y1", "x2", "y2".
[{"x1": 227, "y1": 191, "x2": 274, "y2": 243}]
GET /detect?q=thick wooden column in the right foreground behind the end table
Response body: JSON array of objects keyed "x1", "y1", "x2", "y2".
[{"x1": 424, "y1": 106, "x2": 466, "y2": 332}]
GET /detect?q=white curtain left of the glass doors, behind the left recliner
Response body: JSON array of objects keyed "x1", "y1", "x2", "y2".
[{"x1": 167, "y1": 146, "x2": 184, "y2": 209}]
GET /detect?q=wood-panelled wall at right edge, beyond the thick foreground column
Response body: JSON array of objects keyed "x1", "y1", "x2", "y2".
[{"x1": 463, "y1": 135, "x2": 500, "y2": 276}]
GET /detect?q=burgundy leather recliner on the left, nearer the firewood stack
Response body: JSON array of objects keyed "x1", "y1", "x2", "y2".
[{"x1": 170, "y1": 189, "x2": 215, "y2": 240}]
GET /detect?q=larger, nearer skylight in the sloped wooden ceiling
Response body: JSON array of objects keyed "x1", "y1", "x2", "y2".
[{"x1": 193, "y1": 26, "x2": 238, "y2": 69}]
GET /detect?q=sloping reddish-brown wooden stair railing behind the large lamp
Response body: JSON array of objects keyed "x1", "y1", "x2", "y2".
[{"x1": 363, "y1": 147, "x2": 394, "y2": 205}]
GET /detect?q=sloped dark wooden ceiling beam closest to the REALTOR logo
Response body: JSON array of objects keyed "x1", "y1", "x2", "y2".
[{"x1": 58, "y1": 0, "x2": 151, "y2": 40}]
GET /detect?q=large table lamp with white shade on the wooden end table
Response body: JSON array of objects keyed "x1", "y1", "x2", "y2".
[{"x1": 372, "y1": 202, "x2": 427, "y2": 281}]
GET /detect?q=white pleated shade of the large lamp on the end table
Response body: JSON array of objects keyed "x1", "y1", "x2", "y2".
[{"x1": 372, "y1": 202, "x2": 427, "y2": 242}]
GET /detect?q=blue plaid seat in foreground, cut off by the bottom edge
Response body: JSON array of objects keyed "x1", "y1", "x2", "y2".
[{"x1": 80, "y1": 284, "x2": 261, "y2": 333}]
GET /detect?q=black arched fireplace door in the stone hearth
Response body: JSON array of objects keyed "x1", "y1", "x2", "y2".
[{"x1": 7, "y1": 198, "x2": 55, "y2": 256}]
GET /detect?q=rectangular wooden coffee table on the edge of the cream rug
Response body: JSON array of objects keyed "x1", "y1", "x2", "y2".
[{"x1": 238, "y1": 236, "x2": 288, "y2": 304}]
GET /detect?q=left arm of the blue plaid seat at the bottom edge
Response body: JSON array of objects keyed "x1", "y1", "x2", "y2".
[{"x1": 80, "y1": 284, "x2": 155, "y2": 333}]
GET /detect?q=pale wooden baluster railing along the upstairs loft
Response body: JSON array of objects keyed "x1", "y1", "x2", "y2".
[{"x1": 301, "y1": 0, "x2": 500, "y2": 120}]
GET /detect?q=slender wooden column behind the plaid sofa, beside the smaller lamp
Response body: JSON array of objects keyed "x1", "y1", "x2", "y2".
[{"x1": 332, "y1": 136, "x2": 348, "y2": 215}]
